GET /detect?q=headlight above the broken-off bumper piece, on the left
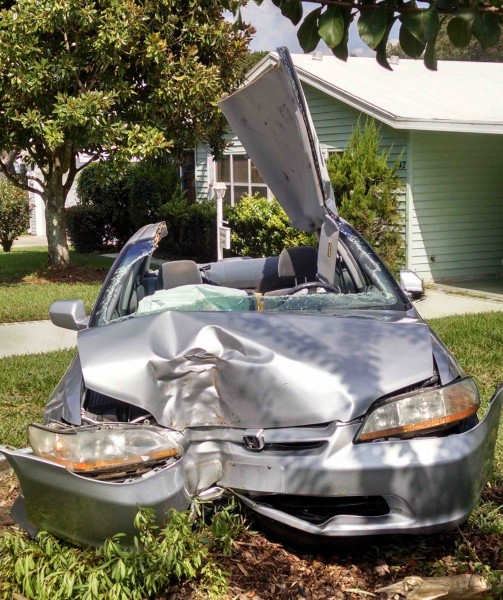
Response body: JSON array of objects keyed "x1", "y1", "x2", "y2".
[{"x1": 28, "y1": 424, "x2": 182, "y2": 473}]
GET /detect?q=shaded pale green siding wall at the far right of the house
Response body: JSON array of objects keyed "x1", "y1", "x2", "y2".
[{"x1": 408, "y1": 131, "x2": 503, "y2": 281}]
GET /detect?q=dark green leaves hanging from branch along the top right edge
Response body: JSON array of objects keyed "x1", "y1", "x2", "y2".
[{"x1": 235, "y1": 0, "x2": 503, "y2": 69}]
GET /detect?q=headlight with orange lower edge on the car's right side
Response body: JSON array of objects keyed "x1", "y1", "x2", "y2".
[{"x1": 356, "y1": 379, "x2": 480, "y2": 442}]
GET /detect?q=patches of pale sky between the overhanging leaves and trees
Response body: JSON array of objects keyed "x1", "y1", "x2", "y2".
[{"x1": 241, "y1": 0, "x2": 378, "y2": 56}]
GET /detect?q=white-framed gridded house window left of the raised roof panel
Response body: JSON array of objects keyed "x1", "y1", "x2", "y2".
[{"x1": 216, "y1": 154, "x2": 268, "y2": 206}]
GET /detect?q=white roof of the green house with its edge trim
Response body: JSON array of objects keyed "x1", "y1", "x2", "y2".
[{"x1": 247, "y1": 53, "x2": 503, "y2": 135}]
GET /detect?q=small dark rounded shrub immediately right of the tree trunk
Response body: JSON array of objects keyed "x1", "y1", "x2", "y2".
[{"x1": 66, "y1": 205, "x2": 106, "y2": 254}]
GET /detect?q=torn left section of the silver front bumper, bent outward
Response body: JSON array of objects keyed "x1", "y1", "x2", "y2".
[{"x1": 4, "y1": 451, "x2": 190, "y2": 546}]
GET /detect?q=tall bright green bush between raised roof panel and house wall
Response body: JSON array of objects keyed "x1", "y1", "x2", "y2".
[{"x1": 328, "y1": 120, "x2": 404, "y2": 271}]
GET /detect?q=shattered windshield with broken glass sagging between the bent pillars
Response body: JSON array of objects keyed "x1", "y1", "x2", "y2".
[{"x1": 94, "y1": 224, "x2": 404, "y2": 325}]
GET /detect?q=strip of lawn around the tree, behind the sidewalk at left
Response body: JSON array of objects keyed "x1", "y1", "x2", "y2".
[{"x1": 0, "y1": 248, "x2": 112, "y2": 323}]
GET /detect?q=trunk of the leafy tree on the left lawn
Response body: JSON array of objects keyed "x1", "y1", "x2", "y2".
[{"x1": 44, "y1": 170, "x2": 70, "y2": 268}]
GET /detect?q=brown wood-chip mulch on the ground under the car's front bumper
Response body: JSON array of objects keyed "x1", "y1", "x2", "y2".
[{"x1": 0, "y1": 470, "x2": 503, "y2": 600}]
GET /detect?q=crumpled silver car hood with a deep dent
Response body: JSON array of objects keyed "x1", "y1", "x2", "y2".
[{"x1": 78, "y1": 311, "x2": 433, "y2": 430}]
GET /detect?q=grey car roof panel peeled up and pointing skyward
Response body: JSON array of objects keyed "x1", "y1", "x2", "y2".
[{"x1": 219, "y1": 49, "x2": 336, "y2": 231}]
